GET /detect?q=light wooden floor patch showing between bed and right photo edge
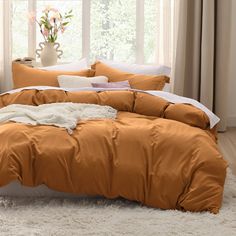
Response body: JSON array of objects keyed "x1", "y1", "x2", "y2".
[{"x1": 218, "y1": 128, "x2": 236, "y2": 175}]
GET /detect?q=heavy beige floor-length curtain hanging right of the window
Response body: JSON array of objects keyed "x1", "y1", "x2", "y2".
[{"x1": 173, "y1": 0, "x2": 232, "y2": 131}]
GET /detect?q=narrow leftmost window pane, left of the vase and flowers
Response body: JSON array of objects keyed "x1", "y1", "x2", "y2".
[{"x1": 12, "y1": 0, "x2": 28, "y2": 60}]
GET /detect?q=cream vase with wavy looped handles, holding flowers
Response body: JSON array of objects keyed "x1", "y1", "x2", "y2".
[{"x1": 36, "y1": 42, "x2": 63, "y2": 66}]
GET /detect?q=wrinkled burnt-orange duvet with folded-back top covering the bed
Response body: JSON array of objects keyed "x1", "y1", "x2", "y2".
[{"x1": 0, "y1": 90, "x2": 227, "y2": 213}]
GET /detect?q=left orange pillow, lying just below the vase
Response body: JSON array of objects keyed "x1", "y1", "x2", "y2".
[{"x1": 12, "y1": 63, "x2": 93, "y2": 89}]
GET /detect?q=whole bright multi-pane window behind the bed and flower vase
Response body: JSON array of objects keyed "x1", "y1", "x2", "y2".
[{"x1": 11, "y1": 0, "x2": 174, "y2": 65}]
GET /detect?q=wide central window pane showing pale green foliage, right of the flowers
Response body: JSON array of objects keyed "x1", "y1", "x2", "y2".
[{"x1": 90, "y1": 0, "x2": 136, "y2": 62}]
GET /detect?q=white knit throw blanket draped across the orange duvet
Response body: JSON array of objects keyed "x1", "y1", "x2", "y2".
[{"x1": 0, "y1": 102, "x2": 117, "y2": 134}]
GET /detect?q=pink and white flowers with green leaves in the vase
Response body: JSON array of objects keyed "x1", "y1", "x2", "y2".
[{"x1": 29, "y1": 6, "x2": 73, "y2": 43}]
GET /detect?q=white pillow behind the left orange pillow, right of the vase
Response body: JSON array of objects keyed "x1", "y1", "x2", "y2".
[{"x1": 39, "y1": 58, "x2": 88, "y2": 71}]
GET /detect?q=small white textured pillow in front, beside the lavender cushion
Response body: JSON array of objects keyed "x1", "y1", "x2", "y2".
[{"x1": 57, "y1": 75, "x2": 108, "y2": 88}]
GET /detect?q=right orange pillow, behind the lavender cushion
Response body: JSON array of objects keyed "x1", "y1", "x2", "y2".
[{"x1": 91, "y1": 61, "x2": 170, "y2": 90}]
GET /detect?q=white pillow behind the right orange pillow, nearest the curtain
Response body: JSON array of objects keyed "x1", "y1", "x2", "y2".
[{"x1": 98, "y1": 59, "x2": 171, "y2": 76}]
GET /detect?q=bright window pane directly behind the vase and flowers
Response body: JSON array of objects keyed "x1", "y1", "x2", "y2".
[{"x1": 37, "y1": 0, "x2": 82, "y2": 62}]
